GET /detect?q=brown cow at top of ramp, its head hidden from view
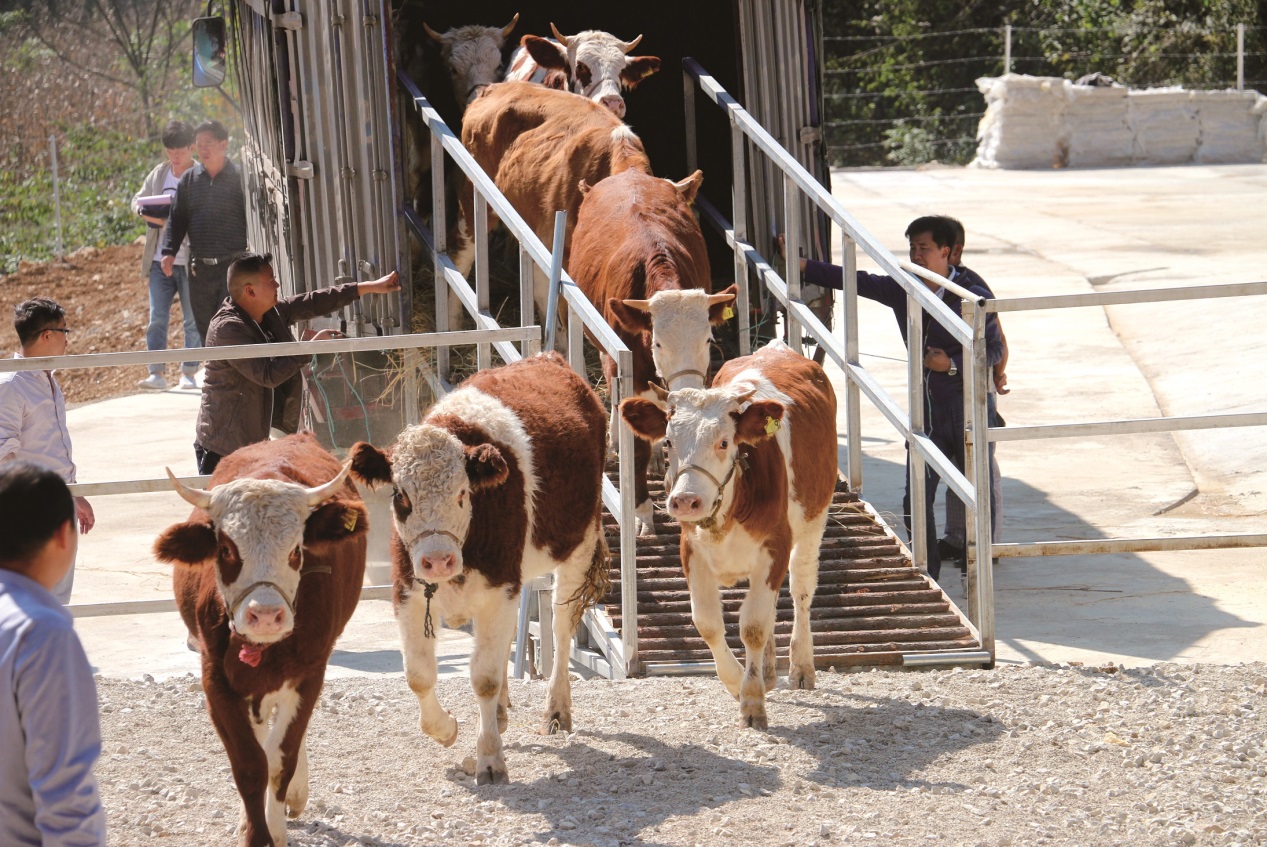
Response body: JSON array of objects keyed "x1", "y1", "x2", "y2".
[{"x1": 450, "y1": 82, "x2": 651, "y2": 328}]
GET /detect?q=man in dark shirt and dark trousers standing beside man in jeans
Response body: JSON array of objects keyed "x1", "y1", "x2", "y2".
[{"x1": 162, "y1": 120, "x2": 246, "y2": 344}]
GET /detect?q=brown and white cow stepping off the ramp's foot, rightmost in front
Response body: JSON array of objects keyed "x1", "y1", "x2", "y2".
[{"x1": 621, "y1": 341, "x2": 836, "y2": 729}]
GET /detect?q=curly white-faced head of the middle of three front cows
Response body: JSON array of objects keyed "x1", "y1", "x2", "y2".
[{"x1": 352, "y1": 424, "x2": 508, "y2": 582}]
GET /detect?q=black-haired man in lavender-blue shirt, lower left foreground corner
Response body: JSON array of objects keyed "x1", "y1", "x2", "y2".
[{"x1": 0, "y1": 460, "x2": 106, "y2": 847}]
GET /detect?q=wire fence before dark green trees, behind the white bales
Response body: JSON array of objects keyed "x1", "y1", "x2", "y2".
[{"x1": 824, "y1": 22, "x2": 1267, "y2": 166}]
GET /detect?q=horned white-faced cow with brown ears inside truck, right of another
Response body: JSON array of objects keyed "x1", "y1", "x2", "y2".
[{"x1": 506, "y1": 23, "x2": 660, "y2": 118}]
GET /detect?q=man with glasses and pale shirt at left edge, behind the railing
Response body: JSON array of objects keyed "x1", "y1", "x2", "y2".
[{"x1": 0, "y1": 298, "x2": 96, "y2": 605}]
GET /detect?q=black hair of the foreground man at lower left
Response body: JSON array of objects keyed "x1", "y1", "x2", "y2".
[{"x1": 0, "y1": 461, "x2": 75, "y2": 570}]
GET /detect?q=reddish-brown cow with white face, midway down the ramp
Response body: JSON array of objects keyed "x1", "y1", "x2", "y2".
[{"x1": 568, "y1": 168, "x2": 737, "y2": 534}]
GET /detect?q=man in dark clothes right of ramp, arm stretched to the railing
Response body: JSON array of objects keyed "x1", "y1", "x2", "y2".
[{"x1": 801, "y1": 216, "x2": 1003, "y2": 579}]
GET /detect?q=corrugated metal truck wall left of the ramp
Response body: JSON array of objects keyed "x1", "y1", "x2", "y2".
[{"x1": 232, "y1": 0, "x2": 408, "y2": 334}]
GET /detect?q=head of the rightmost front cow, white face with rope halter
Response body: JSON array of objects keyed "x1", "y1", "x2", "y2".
[{"x1": 621, "y1": 384, "x2": 783, "y2": 522}]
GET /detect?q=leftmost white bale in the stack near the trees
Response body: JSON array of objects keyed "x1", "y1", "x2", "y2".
[{"x1": 972, "y1": 73, "x2": 1069, "y2": 168}]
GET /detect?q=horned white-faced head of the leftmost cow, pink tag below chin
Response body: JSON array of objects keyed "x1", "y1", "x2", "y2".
[{"x1": 155, "y1": 466, "x2": 366, "y2": 644}]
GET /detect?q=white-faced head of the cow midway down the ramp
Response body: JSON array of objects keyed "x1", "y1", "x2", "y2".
[{"x1": 607, "y1": 285, "x2": 739, "y2": 389}]
